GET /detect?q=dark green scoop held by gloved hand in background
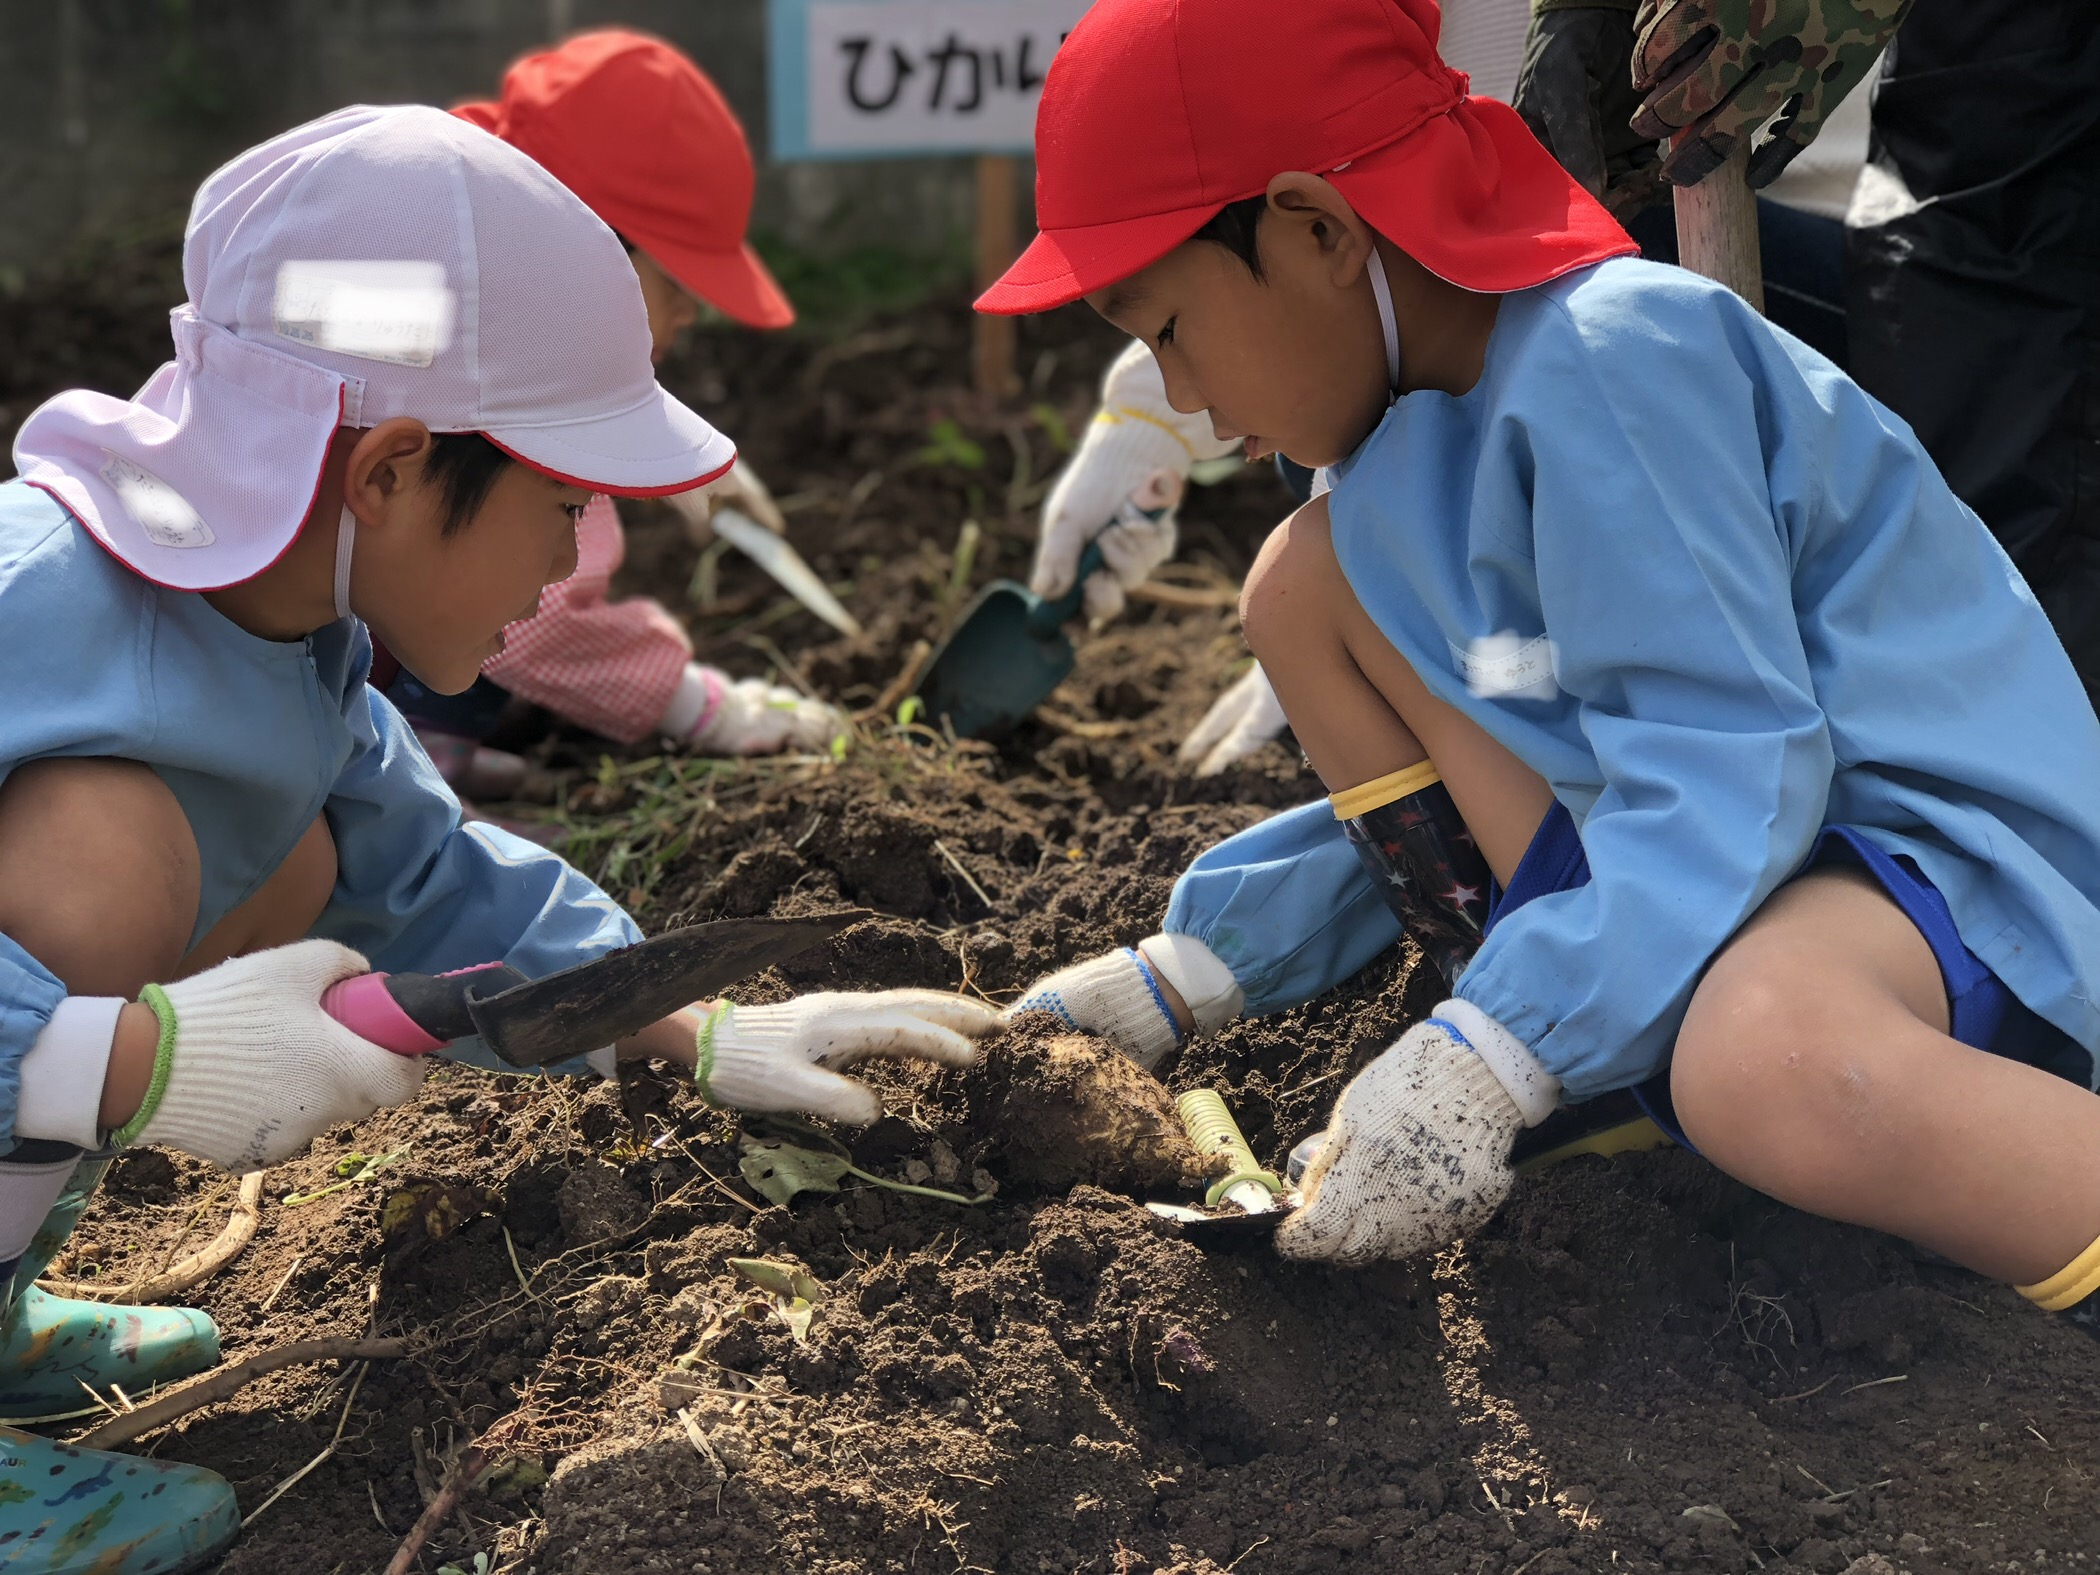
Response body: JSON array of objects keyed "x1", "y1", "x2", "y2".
[{"x1": 918, "y1": 542, "x2": 1103, "y2": 739}]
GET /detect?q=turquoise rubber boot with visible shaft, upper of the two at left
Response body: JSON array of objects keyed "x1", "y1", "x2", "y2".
[{"x1": 0, "y1": 1159, "x2": 218, "y2": 1419}]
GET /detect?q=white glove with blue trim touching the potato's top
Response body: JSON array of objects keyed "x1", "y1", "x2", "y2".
[{"x1": 1006, "y1": 935, "x2": 1245, "y2": 1071}]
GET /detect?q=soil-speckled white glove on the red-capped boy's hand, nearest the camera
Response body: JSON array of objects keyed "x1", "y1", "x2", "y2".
[{"x1": 1277, "y1": 1002, "x2": 1560, "y2": 1264}]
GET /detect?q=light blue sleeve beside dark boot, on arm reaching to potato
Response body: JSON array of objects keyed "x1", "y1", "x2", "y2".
[{"x1": 1166, "y1": 802, "x2": 1401, "y2": 1016}]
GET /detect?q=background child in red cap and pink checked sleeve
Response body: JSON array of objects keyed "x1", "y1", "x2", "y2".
[{"x1": 391, "y1": 27, "x2": 844, "y2": 796}]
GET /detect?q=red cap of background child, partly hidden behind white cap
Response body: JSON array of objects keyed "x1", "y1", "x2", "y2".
[{"x1": 452, "y1": 27, "x2": 794, "y2": 328}]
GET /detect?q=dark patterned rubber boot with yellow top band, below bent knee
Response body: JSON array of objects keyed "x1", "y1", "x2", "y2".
[{"x1": 1327, "y1": 760, "x2": 1493, "y2": 987}]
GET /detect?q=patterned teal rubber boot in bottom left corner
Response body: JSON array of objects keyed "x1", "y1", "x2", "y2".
[{"x1": 0, "y1": 1428, "x2": 242, "y2": 1575}]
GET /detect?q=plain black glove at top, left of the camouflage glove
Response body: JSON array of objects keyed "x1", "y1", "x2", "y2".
[{"x1": 1516, "y1": 0, "x2": 1663, "y2": 223}]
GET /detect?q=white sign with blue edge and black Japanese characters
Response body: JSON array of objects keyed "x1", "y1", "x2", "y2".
[{"x1": 771, "y1": 0, "x2": 1088, "y2": 158}]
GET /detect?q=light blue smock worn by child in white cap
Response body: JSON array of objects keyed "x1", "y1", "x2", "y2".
[{"x1": 0, "y1": 481, "x2": 641, "y2": 1151}]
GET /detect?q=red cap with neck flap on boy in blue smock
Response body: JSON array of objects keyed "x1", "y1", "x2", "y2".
[{"x1": 977, "y1": 0, "x2": 1638, "y2": 313}]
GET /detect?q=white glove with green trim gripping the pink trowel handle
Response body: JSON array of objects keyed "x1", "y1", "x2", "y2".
[{"x1": 111, "y1": 941, "x2": 424, "y2": 1172}]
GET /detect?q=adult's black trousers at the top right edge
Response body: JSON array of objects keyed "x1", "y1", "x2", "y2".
[{"x1": 1846, "y1": 0, "x2": 2100, "y2": 699}]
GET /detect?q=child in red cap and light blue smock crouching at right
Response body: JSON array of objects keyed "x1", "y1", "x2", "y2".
[{"x1": 979, "y1": 0, "x2": 2100, "y2": 1344}]
